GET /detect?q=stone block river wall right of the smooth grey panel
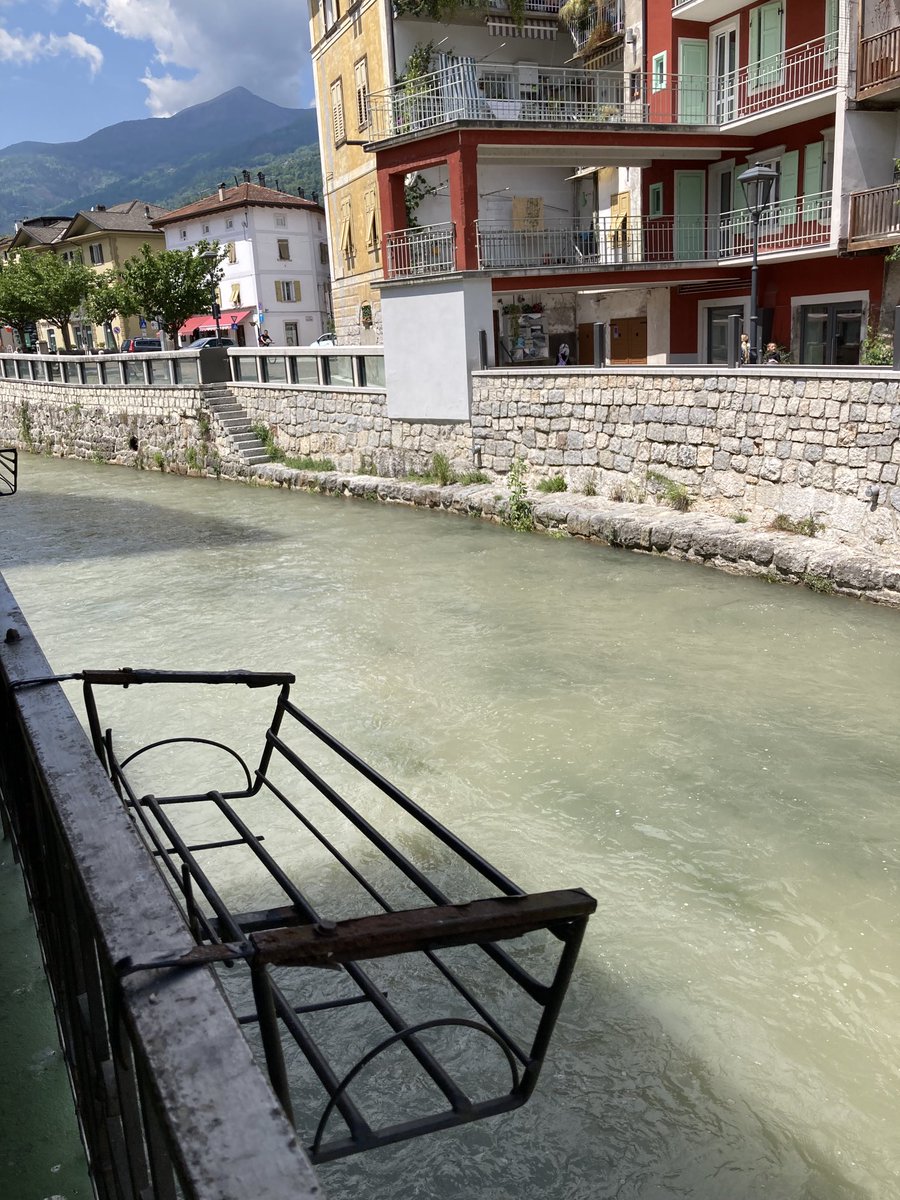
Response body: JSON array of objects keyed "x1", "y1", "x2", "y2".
[{"x1": 472, "y1": 367, "x2": 900, "y2": 546}]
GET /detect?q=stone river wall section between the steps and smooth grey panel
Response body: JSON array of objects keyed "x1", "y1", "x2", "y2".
[{"x1": 232, "y1": 384, "x2": 473, "y2": 475}]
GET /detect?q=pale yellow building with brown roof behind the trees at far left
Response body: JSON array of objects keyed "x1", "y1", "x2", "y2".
[{"x1": 8, "y1": 200, "x2": 168, "y2": 349}]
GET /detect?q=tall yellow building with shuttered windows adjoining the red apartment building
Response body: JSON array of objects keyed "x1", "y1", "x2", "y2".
[{"x1": 310, "y1": 0, "x2": 394, "y2": 344}]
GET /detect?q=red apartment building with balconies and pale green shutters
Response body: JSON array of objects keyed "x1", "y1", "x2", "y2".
[{"x1": 314, "y1": 0, "x2": 900, "y2": 415}]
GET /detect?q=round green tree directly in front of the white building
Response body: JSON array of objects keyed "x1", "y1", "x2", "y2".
[{"x1": 116, "y1": 241, "x2": 224, "y2": 346}]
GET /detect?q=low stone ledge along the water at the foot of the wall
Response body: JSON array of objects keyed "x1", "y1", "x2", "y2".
[{"x1": 242, "y1": 464, "x2": 900, "y2": 607}]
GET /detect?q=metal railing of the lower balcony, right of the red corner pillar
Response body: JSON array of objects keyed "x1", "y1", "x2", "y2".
[{"x1": 478, "y1": 192, "x2": 832, "y2": 271}]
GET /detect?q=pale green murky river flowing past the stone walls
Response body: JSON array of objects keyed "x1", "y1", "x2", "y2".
[{"x1": 0, "y1": 456, "x2": 900, "y2": 1200}]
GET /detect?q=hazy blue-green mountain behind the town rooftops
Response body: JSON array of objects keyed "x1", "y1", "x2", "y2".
[{"x1": 0, "y1": 88, "x2": 322, "y2": 232}]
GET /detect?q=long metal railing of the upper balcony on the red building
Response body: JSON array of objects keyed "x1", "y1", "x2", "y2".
[{"x1": 370, "y1": 30, "x2": 839, "y2": 142}]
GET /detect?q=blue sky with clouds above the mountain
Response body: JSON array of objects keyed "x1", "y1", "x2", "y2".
[{"x1": 0, "y1": 0, "x2": 313, "y2": 147}]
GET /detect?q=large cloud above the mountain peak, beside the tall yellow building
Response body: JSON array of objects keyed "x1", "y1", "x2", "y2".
[{"x1": 78, "y1": 0, "x2": 312, "y2": 116}]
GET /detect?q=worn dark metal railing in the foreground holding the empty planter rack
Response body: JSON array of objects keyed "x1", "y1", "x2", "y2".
[{"x1": 0, "y1": 577, "x2": 322, "y2": 1200}]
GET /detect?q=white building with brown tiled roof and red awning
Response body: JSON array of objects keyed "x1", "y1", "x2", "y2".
[{"x1": 154, "y1": 172, "x2": 331, "y2": 346}]
